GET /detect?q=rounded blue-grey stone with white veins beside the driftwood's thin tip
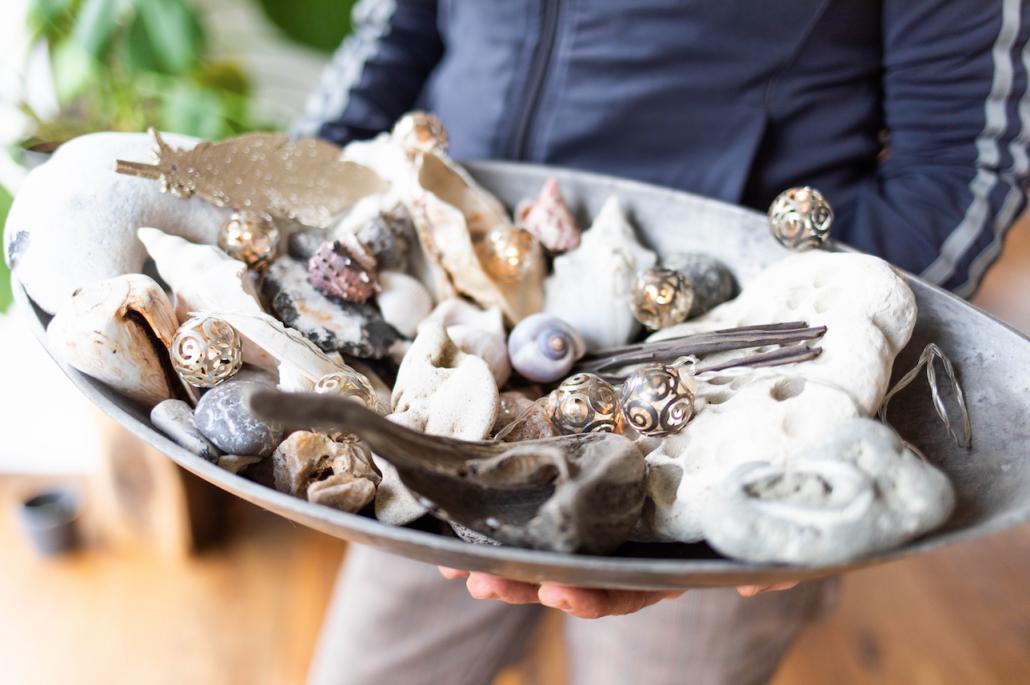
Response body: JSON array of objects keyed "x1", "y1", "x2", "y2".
[{"x1": 195, "y1": 380, "x2": 283, "y2": 456}]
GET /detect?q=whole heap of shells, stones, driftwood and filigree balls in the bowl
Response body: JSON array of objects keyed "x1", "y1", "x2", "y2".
[{"x1": 7, "y1": 112, "x2": 954, "y2": 562}]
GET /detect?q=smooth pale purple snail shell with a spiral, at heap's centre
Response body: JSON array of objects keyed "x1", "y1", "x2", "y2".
[{"x1": 508, "y1": 314, "x2": 586, "y2": 383}]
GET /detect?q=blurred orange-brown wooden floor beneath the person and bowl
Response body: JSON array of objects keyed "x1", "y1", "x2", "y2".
[{"x1": 0, "y1": 222, "x2": 1030, "y2": 685}]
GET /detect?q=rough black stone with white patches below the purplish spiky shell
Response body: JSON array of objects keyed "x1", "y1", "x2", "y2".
[{"x1": 262, "y1": 256, "x2": 400, "y2": 359}]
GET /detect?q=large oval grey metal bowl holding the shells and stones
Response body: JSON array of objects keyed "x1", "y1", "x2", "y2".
[{"x1": 15, "y1": 163, "x2": 1030, "y2": 589}]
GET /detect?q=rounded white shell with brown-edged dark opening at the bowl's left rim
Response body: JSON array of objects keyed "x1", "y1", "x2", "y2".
[{"x1": 46, "y1": 274, "x2": 193, "y2": 407}]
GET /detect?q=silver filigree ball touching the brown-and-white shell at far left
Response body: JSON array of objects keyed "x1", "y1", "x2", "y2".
[{"x1": 169, "y1": 316, "x2": 243, "y2": 387}]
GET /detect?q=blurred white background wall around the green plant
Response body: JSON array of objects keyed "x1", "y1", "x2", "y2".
[{"x1": 0, "y1": 0, "x2": 327, "y2": 473}]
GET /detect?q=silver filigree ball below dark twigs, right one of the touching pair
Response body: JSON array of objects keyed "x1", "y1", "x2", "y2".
[{"x1": 619, "y1": 364, "x2": 694, "y2": 436}]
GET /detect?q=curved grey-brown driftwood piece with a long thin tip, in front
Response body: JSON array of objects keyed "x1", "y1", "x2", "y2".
[{"x1": 250, "y1": 390, "x2": 646, "y2": 553}]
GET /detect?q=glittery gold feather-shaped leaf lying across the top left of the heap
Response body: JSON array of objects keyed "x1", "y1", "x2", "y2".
[{"x1": 115, "y1": 129, "x2": 386, "y2": 229}]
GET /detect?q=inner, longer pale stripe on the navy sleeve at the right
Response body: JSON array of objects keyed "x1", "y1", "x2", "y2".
[{"x1": 923, "y1": 0, "x2": 1021, "y2": 283}]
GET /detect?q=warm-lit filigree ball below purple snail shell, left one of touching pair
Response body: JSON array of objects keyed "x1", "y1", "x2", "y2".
[{"x1": 547, "y1": 373, "x2": 621, "y2": 435}]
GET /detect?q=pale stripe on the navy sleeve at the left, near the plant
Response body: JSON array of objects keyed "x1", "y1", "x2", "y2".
[{"x1": 290, "y1": 0, "x2": 397, "y2": 138}]
